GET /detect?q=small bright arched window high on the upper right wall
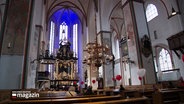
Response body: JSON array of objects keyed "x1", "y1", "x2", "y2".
[{"x1": 146, "y1": 4, "x2": 158, "y2": 22}]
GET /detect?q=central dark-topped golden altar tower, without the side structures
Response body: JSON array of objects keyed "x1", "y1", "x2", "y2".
[{"x1": 54, "y1": 39, "x2": 77, "y2": 80}]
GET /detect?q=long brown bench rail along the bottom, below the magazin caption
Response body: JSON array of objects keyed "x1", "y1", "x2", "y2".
[{"x1": 9, "y1": 96, "x2": 121, "y2": 104}]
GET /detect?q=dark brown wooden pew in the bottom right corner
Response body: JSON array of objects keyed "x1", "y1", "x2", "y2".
[{"x1": 153, "y1": 88, "x2": 184, "y2": 104}]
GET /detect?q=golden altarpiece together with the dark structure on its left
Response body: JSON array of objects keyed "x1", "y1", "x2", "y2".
[{"x1": 36, "y1": 40, "x2": 78, "y2": 90}]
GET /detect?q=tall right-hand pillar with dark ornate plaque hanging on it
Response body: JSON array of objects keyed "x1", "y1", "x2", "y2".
[{"x1": 122, "y1": 0, "x2": 156, "y2": 84}]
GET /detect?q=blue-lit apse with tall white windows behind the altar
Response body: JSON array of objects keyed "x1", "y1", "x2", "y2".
[{"x1": 49, "y1": 8, "x2": 81, "y2": 70}]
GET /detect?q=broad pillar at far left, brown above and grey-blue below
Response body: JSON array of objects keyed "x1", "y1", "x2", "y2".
[{"x1": 0, "y1": 0, "x2": 32, "y2": 89}]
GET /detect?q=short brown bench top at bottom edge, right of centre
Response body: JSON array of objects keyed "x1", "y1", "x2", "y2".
[{"x1": 74, "y1": 97, "x2": 150, "y2": 104}]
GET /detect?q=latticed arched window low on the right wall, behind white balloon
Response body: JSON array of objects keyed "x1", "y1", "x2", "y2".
[{"x1": 159, "y1": 48, "x2": 172, "y2": 71}]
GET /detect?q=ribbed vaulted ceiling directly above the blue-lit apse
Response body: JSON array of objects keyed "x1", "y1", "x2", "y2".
[{"x1": 46, "y1": 0, "x2": 95, "y2": 24}]
